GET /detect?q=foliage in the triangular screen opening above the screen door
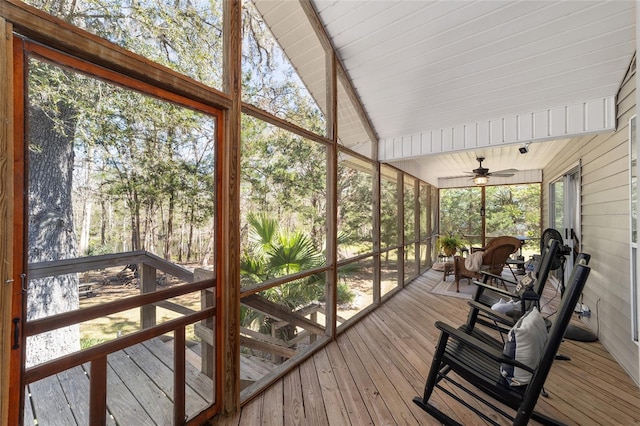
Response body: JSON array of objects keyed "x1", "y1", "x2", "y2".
[{"x1": 27, "y1": 0, "x2": 223, "y2": 89}]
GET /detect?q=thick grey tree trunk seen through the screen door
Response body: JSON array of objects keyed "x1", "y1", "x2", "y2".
[{"x1": 26, "y1": 105, "x2": 80, "y2": 366}]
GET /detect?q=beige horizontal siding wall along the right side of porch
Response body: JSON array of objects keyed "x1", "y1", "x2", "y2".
[{"x1": 543, "y1": 66, "x2": 640, "y2": 383}]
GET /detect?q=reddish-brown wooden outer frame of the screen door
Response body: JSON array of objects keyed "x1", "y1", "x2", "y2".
[{"x1": 0, "y1": 32, "x2": 225, "y2": 424}]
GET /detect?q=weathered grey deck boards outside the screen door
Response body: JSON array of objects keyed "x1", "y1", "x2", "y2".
[{"x1": 24, "y1": 338, "x2": 213, "y2": 426}]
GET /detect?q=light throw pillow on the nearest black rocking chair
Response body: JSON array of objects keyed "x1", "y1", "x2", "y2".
[{"x1": 500, "y1": 307, "x2": 547, "y2": 386}]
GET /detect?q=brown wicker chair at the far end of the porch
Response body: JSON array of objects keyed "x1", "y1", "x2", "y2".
[{"x1": 453, "y1": 236, "x2": 522, "y2": 291}]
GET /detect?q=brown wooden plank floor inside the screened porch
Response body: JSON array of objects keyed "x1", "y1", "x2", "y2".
[{"x1": 216, "y1": 272, "x2": 640, "y2": 425}]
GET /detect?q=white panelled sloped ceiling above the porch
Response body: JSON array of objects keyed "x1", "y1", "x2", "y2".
[{"x1": 256, "y1": 0, "x2": 635, "y2": 184}]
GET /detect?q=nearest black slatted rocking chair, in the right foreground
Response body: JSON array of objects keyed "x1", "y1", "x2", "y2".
[{"x1": 413, "y1": 264, "x2": 590, "y2": 425}]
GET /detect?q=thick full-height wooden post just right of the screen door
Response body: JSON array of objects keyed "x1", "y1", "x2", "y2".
[{"x1": 216, "y1": 0, "x2": 242, "y2": 412}]
